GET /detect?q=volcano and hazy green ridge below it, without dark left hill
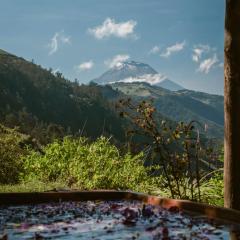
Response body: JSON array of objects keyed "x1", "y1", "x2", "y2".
[{"x1": 93, "y1": 61, "x2": 224, "y2": 138}]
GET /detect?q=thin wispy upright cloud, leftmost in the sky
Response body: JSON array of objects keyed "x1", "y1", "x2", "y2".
[{"x1": 48, "y1": 31, "x2": 71, "y2": 55}]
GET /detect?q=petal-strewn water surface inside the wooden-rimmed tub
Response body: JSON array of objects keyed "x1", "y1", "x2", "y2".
[{"x1": 0, "y1": 201, "x2": 240, "y2": 240}]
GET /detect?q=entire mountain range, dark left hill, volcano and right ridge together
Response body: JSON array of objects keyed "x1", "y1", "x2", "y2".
[{"x1": 0, "y1": 50, "x2": 223, "y2": 141}]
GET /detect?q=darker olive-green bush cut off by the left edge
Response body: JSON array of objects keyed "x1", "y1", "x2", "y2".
[{"x1": 0, "y1": 125, "x2": 28, "y2": 184}]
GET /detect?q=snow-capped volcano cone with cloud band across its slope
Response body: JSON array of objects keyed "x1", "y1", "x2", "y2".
[{"x1": 93, "y1": 61, "x2": 184, "y2": 91}]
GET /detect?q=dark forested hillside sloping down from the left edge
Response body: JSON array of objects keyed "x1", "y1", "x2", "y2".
[{"x1": 0, "y1": 50, "x2": 124, "y2": 142}]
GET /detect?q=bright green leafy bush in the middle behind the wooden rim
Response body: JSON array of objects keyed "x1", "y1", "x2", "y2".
[{"x1": 22, "y1": 137, "x2": 150, "y2": 191}]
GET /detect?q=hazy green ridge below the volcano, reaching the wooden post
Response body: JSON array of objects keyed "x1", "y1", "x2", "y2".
[{"x1": 111, "y1": 82, "x2": 224, "y2": 138}]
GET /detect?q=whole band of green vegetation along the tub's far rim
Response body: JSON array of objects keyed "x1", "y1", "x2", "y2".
[{"x1": 0, "y1": 119, "x2": 223, "y2": 205}]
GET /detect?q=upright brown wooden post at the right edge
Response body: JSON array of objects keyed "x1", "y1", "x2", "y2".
[{"x1": 224, "y1": 0, "x2": 240, "y2": 210}]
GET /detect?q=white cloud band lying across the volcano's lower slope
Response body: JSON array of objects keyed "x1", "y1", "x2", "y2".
[{"x1": 112, "y1": 74, "x2": 167, "y2": 85}]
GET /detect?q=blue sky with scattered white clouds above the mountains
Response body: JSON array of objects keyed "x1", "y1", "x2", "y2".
[{"x1": 0, "y1": 0, "x2": 225, "y2": 94}]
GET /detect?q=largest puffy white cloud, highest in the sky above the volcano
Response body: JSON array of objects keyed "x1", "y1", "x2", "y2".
[{"x1": 88, "y1": 18, "x2": 137, "y2": 39}]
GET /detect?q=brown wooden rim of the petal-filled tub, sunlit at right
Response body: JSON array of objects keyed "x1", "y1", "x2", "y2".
[{"x1": 0, "y1": 190, "x2": 240, "y2": 224}]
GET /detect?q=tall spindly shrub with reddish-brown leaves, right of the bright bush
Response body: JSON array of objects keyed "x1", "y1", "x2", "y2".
[{"x1": 117, "y1": 99, "x2": 221, "y2": 201}]
